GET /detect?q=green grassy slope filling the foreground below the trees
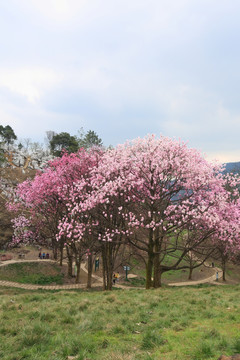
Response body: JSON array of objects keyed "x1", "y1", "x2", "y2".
[{"x1": 0, "y1": 285, "x2": 240, "y2": 360}]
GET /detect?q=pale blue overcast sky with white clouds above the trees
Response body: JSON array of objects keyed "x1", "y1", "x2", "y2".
[{"x1": 0, "y1": 0, "x2": 240, "y2": 161}]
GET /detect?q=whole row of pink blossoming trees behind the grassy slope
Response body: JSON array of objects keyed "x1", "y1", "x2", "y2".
[{"x1": 6, "y1": 136, "x2": 240, "y2": 289}]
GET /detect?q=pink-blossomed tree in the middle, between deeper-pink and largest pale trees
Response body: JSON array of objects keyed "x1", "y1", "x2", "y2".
[{"x1": 59, "y1": 150, "x2": 133, "y2": 290}]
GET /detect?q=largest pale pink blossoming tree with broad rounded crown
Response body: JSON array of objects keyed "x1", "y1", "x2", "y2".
[{"x1": 84, "y1": 136, "x2": 238, "y2": 288}]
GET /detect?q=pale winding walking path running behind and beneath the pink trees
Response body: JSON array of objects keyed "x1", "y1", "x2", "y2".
[{"x1": 0, "y1": 260, "x2": 222, "y2": 290}]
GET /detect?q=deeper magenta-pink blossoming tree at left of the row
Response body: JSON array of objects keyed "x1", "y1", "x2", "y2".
[{"x1": 10, "y1": 149, "x2": 101, "y2": 273}]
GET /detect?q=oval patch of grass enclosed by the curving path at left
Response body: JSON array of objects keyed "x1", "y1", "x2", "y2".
[{"x1": 0, "y1": 262, "x2": 64, "y2": 285}]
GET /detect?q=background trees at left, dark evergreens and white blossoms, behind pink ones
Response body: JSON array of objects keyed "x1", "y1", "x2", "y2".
[{"x1": 0, "y1": 125, "x2": 102, "y2": 248}]
